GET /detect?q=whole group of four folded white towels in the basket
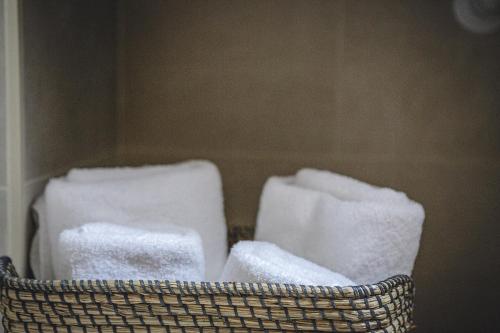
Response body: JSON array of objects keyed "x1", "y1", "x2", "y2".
[{"x1": 31, "y1": 161, "x2": 425, "y2": 286}]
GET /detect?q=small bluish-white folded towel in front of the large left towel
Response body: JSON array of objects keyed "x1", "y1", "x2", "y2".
[{"x1": 58, "y1": 222, "x2": 205, "y2": 281}]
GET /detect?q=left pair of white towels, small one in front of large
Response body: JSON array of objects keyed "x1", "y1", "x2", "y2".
[{"x1": 31, "y1": 161, "x2": 227, "y2": 280}]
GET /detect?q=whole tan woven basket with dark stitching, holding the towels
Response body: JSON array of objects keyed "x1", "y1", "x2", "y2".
[{"x1": 0, "y1": 228, "x2": 414, "y2": 333}]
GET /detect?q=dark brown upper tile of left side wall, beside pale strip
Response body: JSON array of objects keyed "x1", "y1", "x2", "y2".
[{"x1": 23, "y1": 0, "x2": 116, "y2": 180}]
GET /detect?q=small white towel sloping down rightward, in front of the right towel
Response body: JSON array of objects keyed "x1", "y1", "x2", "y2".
[{"x1": 220, "y1": 241, "x2": 356, "y2": 286}]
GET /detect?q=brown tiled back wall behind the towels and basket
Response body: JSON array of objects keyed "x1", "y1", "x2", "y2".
[{"x1": 118, "y1": 0, "x2": 500, "y2": 332}]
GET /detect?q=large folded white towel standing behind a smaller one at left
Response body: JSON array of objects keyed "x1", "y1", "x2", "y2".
[{"x1": 37, "y1": 161, "x2": 227, "y2": 280}]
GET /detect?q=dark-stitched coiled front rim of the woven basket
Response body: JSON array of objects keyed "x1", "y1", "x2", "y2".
[{"x1": 0, "y1": 256, "x2": 414, "y2": 299}]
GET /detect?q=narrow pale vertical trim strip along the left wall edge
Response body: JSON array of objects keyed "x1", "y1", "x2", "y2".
[{"x1": 4, "y1": 0, "x2": 27, "y2": 275}]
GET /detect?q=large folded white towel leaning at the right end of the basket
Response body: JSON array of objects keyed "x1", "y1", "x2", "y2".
[{"x1": 255, "y1": 169, "x2": 425, "y2": 283}]
